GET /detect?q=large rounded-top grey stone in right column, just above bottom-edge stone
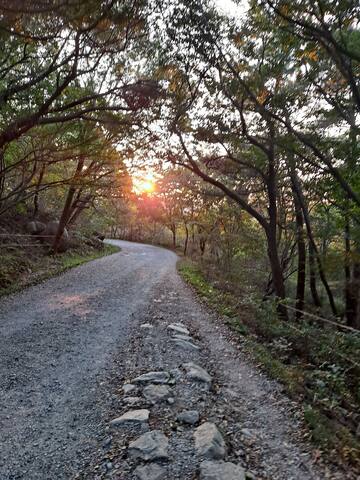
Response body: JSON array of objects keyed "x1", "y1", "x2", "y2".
[{"x1": 194, "y1": 422, "x2": 226, "y2": 460}]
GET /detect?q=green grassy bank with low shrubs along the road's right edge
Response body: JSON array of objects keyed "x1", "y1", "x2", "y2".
[{"x1": 178, "y1": 260, "x2": 360, "y2": 469}]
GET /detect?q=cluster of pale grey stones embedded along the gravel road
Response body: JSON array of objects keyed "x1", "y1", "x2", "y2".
[{"x1": 111, "y1": 324, "x2": 249, "y2": 480}]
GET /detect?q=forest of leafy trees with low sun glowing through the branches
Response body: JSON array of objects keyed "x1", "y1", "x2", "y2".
[{"x1": 0, "y1": 0, "x2": 360, "y2": 472}]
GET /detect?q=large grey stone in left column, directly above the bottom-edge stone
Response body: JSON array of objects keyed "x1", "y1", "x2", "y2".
[{"x1": 129, "y1": 430, "x2": 169, "y2": 461}]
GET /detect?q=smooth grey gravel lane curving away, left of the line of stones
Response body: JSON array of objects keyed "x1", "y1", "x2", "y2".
[{"x1": 0, "y1": 241, "x2": 177, "y2": 480}]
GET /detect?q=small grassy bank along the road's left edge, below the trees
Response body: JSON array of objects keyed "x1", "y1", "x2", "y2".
[{"x1": 0, "y1": 244, "x2": 120, "y2": 297}]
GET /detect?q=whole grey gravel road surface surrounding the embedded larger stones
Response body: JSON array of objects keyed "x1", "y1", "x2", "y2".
[{"x1": 0, "y1": 241, "x2": 357, "y2": 480}]
